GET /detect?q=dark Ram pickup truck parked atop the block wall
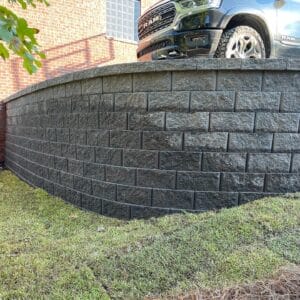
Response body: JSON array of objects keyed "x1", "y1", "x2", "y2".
[{"x1": 137, "y1": 0, "x2": 300, "y2": 61}]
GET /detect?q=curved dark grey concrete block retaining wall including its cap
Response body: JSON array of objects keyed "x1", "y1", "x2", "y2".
[{"x1": 2, "y1": 59, "x2": 300, "y2": 218}]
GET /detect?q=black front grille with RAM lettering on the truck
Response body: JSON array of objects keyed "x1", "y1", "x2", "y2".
[{"x1": 138, "y1": 2, "x2": 176, "y2": 40}]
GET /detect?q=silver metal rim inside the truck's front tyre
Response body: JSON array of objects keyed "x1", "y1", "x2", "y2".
[{"x1": 226, "y1": 34, "x2": 263, "y2": 58}]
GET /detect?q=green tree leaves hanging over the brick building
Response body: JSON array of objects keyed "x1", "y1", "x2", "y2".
[{"x1": 0, "y1": 0, "x2": 49, "y2": 74}]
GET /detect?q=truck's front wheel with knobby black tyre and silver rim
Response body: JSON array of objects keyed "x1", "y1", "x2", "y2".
[{"x1": 215, "y1": 26, "x2": 266, "y2": 58}]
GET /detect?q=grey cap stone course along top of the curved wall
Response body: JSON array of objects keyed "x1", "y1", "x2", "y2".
[{"x1": 0, "y1": 58, "x2": 300, "y2": 103}]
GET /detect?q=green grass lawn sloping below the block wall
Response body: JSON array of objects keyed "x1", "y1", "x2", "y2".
[{"x1": 0, "y1": 171, "x2": 300, "y2": 299}]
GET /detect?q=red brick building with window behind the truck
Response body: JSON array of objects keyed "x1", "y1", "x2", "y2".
[{"x1": 0, "y1": 0, "x2": 157, "y2": 100}]
